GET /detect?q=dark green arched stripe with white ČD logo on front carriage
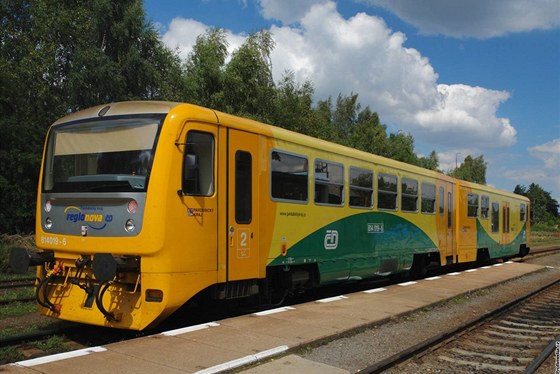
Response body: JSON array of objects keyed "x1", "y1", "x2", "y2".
[{"x1": 269, "y1": 212, "x2": 437, "y2": 283}]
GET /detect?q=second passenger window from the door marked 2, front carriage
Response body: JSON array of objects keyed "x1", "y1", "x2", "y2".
[{"x1": 315, "y1": 160, "x2": 344, "y2": 205}]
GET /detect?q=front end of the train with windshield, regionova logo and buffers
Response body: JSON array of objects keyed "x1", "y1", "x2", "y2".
[{"x1": 11, "y1": 104, "x2": 176, "y2": 330}]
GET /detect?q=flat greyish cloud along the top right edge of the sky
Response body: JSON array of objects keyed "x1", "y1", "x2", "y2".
[{"x1": 361, "y1": 0, "x2": 560, "y2": 39}]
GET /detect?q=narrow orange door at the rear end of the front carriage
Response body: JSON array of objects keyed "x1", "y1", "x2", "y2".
[{"x1": 436, "y1": 181, "x2": 456, "y2": 264}]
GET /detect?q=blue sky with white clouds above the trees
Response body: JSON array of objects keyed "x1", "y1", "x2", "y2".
[{"x1": 144, "y1": 0, "x2": 560, "y2": 201}]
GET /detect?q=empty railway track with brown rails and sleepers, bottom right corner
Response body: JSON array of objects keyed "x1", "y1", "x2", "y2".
[{"x1": 362, "y1": 280, "x2": 560, "y2": 373}]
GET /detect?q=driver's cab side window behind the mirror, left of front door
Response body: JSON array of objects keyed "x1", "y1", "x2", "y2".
[{"x1": 182, "y1": 131, "x2": 214, "y2": 196}]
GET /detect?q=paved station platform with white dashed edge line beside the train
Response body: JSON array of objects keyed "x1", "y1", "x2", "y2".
[{"x1": 0, "y1": 262, "x2": 543, "y2": 374}]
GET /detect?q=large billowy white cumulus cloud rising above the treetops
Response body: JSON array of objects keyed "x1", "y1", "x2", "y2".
[{"x1": 163, "y1": 0, "x2": 516, "y2": 148}]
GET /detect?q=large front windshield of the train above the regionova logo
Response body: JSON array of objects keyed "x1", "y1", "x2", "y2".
[{"x1": 43, "y1": 115, "x2": 163, "y2": 192}]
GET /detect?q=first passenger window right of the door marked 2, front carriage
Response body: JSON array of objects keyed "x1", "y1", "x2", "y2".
[{"x1": 270, "y1": 151, "x2": 309, "y2": 202}]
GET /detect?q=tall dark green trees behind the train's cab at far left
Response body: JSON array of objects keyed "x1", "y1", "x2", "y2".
[{"x1": 0, "y1": 0, "x2": 182, "y2": 233}]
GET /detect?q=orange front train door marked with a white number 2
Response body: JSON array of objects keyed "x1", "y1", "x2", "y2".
[{"x1": 227, "y1": 129, "x2": 259, "y2": 281}]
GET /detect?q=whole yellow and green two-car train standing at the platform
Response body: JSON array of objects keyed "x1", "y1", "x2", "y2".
[{"x1": 11, "y1": 102, "x2": 530, "y2": 330}]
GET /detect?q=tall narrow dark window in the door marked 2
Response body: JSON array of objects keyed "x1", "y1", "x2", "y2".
[{"x1": 235, "y1": 151, "x2": 253, "y2": 224}]
